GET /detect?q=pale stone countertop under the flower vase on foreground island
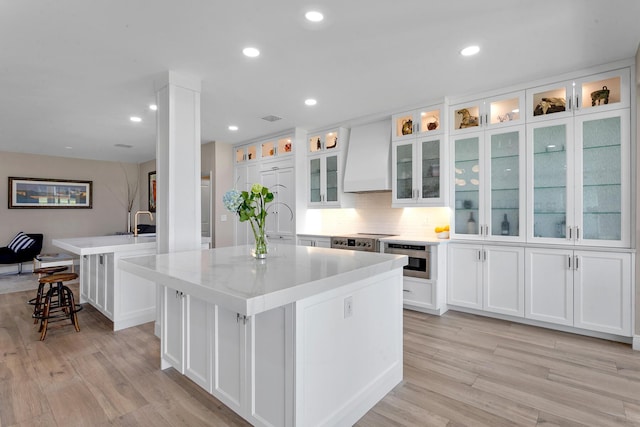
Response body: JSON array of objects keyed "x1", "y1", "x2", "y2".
[{"x1": 119, "y1": 244, "x2": 408, "y2": 316}]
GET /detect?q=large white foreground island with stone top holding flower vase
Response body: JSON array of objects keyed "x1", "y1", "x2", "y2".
[{"x1": 119, "y1": 245, "x2": 407, "y2": 426}]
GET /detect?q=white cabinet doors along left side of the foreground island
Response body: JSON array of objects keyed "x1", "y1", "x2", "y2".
[{"x1": 161, "y1": 286, "x2": 294, "y2": 426}]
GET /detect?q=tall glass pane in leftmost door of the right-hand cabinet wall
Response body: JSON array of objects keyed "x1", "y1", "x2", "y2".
[{"x1": 454, "y1": 137, "x2": 480, "y2": 234}]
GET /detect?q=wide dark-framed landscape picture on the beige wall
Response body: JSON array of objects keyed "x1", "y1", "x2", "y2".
[{"x1": 9, "y1": 176, "x2": 93, "y2": 209}]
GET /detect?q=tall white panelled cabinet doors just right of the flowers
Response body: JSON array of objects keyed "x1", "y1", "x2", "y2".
[{"x1": 260, "y1": 162, "x2": 295, "y2": 244}]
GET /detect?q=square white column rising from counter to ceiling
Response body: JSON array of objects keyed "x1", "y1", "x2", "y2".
[{"x1": 156, "y1": 71, "x2": 201, "y2": 253}]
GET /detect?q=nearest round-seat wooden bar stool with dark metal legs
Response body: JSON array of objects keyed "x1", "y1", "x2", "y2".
[{"x1": 33, "y1": 273, "x2": 82, "y2": 341}]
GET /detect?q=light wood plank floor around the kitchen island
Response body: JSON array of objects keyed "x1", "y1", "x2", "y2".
[{"x1": 0, "y1": 288, "x2": 640, "y2": 427}]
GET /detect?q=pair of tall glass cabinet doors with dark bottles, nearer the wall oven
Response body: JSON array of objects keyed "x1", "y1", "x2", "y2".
[{"x1": 453, "y1": 125, "x2": 526, "y2": 241}]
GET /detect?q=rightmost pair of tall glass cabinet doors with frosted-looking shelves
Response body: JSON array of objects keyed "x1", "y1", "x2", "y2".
[{"x1": 528, "y1": 109, "x2": 631, "y2": 247}]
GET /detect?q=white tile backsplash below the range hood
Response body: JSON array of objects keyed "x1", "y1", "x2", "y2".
[{"x1": 298, "y1": 191, "x2": 450, "y2": 236}]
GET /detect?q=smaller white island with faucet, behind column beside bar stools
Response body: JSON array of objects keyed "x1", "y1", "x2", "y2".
[{"x1": 52, "y1": 235, "x2": 156, "y2": 331}]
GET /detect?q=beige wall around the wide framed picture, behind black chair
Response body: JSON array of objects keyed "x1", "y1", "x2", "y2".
[{"x1": 0, "y1": 152, "x2": 138, "y2": 252}]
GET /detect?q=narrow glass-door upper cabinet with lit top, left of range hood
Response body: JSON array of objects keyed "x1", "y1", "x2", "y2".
[{"x1": 307, "y1": 128, "x2": 353, "y2": 208}]
